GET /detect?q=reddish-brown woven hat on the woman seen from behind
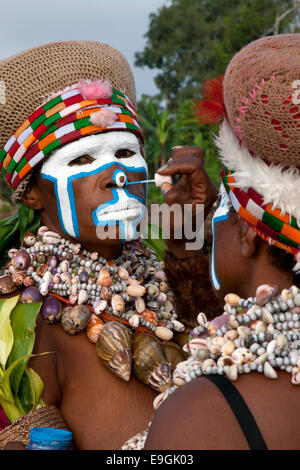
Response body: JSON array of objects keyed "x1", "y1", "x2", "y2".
[{"x1": 223, "y1": 34, "x2": 300, "y2": 166}]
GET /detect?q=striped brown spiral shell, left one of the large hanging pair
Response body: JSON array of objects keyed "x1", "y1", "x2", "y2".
[{"x1": 96, "y1": 322, "x2": 132, "y2": 382}]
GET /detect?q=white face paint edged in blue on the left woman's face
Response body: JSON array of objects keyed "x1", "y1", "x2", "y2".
[{"x1": 41, "y1": 131, "x2": 148, "y2": 240}]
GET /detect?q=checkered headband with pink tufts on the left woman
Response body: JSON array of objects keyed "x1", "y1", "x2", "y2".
[{"x1": 0, "y1": 82, "x2": 143, "y2": 190}]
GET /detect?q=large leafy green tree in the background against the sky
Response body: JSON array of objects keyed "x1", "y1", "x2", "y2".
[{"x1": 135, "y1": 0, "x2": 293, "y2": 106}]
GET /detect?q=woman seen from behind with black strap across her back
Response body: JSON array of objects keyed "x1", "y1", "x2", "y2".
[{"x1": 139, "y1": 35, "x2": 300, "y2": 449}]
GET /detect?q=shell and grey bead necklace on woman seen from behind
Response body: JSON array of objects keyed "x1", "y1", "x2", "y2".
[{"x1": 154, "y1": 284, "x2": 300, "y2": 409}]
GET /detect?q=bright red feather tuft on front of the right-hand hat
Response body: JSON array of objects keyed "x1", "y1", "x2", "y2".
[{"x1": 194, "y1": 75, "x2": 225, "y2": 124}]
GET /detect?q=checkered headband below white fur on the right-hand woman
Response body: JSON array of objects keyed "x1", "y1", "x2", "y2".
[{"x1": 221, "y1": 167, "x2": 300, "y2": 254}]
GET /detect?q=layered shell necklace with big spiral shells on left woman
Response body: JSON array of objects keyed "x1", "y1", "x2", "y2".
[{"x1": 0, "y1": 227, "x2": 185, "y2": 392}]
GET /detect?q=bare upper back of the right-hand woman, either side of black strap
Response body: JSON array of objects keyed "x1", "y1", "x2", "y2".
[{"x1": 145, "y1": 372, "x2": 300, "y2": 450}]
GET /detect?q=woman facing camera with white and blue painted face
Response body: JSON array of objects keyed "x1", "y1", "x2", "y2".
[{"x1": 0, "y1": 41, "x2": 192, "y2": 449}]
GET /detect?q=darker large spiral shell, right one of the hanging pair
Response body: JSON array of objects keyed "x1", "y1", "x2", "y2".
[{"x1": 133, "y1": 333, "x2": 172, "y2": 392}]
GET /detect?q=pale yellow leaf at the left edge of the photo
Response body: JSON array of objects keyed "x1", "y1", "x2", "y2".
[{"x1": 0, "y1": 295, "x2": 19, "y2": 370}]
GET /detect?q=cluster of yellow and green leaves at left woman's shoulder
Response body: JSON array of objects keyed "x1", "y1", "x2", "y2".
[{"x1": 0, "y1": 296, "x2": 44, "y2": 422}]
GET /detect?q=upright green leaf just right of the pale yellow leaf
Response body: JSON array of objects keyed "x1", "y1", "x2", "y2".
[{"x1": 7, "y1": 302, "x2": 42, "y2": 395}]
